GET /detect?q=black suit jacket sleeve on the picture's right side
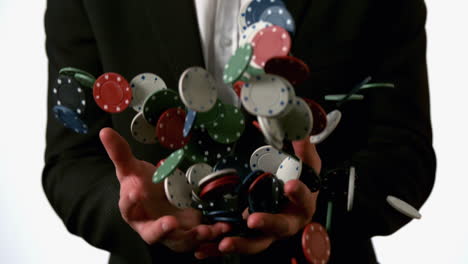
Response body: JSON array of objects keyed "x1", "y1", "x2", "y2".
[{"x1": 325, "y1": 0, "x2": 436, "y2": 237}]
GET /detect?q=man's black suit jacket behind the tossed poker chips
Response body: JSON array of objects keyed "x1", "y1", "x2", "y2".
[{"x1": 43, "y1": 0, "x2": 435, "y2": 263}]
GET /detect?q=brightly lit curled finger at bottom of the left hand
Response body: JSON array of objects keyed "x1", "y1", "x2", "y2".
[{"x1": 134, "y1": 215, "x2": 179, "y2": 244}]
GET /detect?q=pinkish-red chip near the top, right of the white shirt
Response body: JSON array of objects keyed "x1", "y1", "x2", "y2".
[{"x1": 252, "y1": 26, "x2": 291, "y2": 67}]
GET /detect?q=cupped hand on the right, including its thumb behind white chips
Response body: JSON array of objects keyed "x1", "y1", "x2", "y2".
[{"x1": 195, "y1": 139, "x2": 322, "y2": 258}]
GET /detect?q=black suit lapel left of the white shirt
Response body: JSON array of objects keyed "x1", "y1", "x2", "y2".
[{"x1": 143, "y1": 0, "x2": 204, "y2": 84}]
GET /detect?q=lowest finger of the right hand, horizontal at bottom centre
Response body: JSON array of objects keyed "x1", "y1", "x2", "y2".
[{"x1": 218, "y1": 236, "x2": 275, "y2": 255}]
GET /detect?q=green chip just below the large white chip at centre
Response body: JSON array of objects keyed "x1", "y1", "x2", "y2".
[{"x1": 207, "y1": 104, "x2": 245, "y2": 144}]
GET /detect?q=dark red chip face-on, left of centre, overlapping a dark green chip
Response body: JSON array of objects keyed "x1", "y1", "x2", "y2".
[{"x1": 156, "y1": 108, "x2": 192, "y2": 149}]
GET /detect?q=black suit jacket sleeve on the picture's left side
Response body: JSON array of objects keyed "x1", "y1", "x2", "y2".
[{"x1": 42, "y1": 0, "x2": 152, "y2": 263}]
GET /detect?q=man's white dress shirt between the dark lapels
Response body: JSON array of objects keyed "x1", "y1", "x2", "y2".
[{"x1": 194, "y1": 0, "x2": 247, "y2": 105}]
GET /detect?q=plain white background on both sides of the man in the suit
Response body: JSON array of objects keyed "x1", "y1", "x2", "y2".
[{"x1": 0, "y1": 0, "x2": 468, "y2": 264}]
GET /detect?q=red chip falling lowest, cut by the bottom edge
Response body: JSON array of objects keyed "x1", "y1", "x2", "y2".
[{"x1": 302, "y1": 223, "x2": 330, "y2": 264}]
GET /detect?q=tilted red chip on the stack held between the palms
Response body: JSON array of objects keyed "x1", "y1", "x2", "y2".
[{"x1": 199, "y1": 175, "x2": 240, "y2": 199}]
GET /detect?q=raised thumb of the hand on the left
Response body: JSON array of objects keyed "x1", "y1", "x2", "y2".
[{"x1": 99, "y1": 127, "x2": 135, "y2": 177}]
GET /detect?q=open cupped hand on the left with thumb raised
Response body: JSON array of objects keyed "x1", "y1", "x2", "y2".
[{"x1": 99, "y1": 128, "x2": 229, "y2": 252}]
